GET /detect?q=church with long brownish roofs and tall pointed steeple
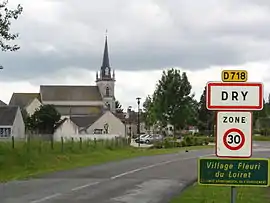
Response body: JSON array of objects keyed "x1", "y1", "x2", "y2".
[{"x1": 10, "y1": 36, "x2": 116, "y2": 118}]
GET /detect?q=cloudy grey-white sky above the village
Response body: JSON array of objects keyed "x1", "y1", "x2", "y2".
[{"x1": 0, "y1": 0, "x2": 270, "y2": 109}]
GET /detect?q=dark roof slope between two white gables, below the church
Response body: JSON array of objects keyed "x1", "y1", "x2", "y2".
[{"x1": 70, "y1": 113, "x2": 103, "y2": 127}]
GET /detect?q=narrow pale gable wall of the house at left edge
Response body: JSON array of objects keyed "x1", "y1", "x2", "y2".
[{"x1": 11, "y1": 108, "x2": 25, "y2": 138}]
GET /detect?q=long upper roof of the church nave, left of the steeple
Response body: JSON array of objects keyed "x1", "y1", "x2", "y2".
[{"x1": 40, "y1": 85, "x2": 102, "y2": 101}]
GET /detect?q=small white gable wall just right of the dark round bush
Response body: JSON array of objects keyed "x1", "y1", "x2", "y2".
[{"x1": 54, "y1": 119, "x2": 79, "y2": 140}]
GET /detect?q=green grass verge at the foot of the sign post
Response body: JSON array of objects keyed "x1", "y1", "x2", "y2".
[{"x1": 171, "y1": 185, "x2": 270, "y2": 203}]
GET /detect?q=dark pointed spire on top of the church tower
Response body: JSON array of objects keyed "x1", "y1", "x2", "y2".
[{"x1": 100, "y1": 30, "x2": 112, "y2": 80}]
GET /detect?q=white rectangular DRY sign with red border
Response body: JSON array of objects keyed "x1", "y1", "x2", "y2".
[{"x1": 206, "y1": 82, "x2": 263, "y2": 110}]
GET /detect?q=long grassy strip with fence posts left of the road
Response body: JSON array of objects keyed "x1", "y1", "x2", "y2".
[{"x1": 0, "y1": 140, "x2": 211, "y2": 182}]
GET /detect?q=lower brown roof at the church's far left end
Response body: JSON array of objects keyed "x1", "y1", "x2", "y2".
[{"x1": 9, "y1": 93, "x2": 40, "y2": 108}]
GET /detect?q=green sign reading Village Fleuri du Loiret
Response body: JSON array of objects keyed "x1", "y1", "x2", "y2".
[{"x1": 198, "y1": 158, "x2": 270, "y2": 187}]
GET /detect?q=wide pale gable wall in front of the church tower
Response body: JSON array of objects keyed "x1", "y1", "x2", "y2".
[{"x1": 87, "y1": 111, "x2": 125, "y2": 137}]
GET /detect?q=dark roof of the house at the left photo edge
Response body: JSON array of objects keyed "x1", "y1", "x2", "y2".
[{"x1": 0, "y1": 106, "x2": 18, "y2": 126}]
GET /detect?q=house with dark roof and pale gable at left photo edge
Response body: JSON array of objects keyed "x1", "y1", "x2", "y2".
[{"x1": 0, "y1": 106, "x2": 25, "y2": 139}]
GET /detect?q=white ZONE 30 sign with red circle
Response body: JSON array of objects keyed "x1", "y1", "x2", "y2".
[{"x1": 216, "y1": 111, "x2": 252, "y2": 158}]
